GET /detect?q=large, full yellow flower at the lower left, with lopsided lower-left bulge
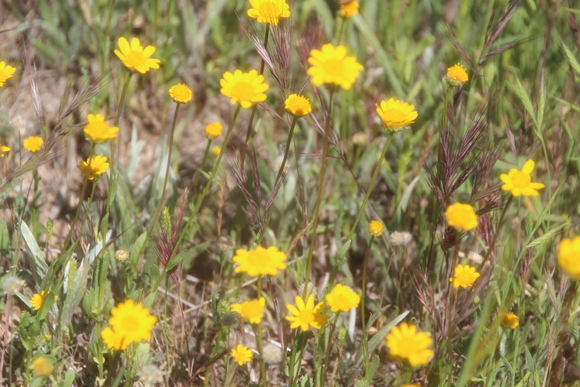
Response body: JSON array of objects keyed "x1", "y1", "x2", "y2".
[{"x1": 101, "y1": 300, "x2": 157, "y2": 350}]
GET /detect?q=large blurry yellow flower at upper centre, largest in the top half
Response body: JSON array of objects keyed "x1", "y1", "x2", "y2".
[{"x1": 307, "y1": 44, "x2": 363, "y2": 90}]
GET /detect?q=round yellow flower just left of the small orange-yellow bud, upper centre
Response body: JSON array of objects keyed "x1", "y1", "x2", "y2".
[{"x1": 220, "y1": 70, "x2": 268, "y2": 109}]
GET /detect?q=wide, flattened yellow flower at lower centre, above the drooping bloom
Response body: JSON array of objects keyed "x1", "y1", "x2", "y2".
[{"x1": 232, "y1": 246, "x2": 286, "y2": 277}]
